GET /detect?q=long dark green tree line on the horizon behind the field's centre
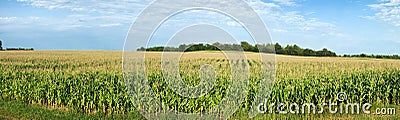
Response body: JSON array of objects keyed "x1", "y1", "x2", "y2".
[{"x1": 137, "y1": 42, "x2": 337, "y2": 57}]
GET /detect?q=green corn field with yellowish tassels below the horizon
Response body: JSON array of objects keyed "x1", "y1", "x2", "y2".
[{"x1": 0, "y1": 51, "x2": 400, "y2": 115}]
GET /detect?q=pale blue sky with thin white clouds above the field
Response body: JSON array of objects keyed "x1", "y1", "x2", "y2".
[{"x1": 0, "y1": 0, "x2": 400, "y2": 54}]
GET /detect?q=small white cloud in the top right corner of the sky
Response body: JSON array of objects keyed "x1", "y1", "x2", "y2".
[{"x1": 363, "y1": 0, "x2": 400, "y2": 27}]
